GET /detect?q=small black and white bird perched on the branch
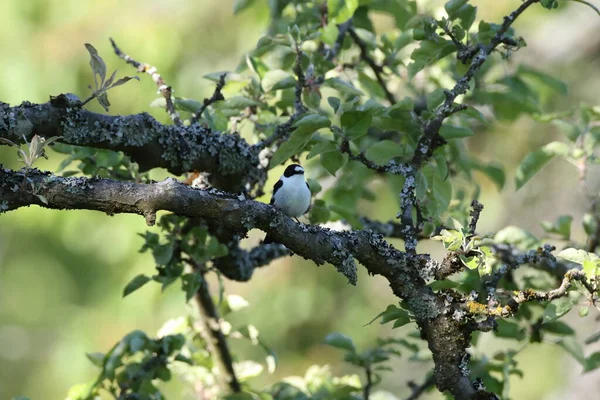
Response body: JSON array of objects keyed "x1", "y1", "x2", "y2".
[{"x1": 263, "y1": 164, "x2": 311, "y2": 243}]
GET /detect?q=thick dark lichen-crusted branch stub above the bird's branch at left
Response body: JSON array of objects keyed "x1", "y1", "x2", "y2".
[{"x1": 0, "y1": 95, "x2": 259, "y2": 191}]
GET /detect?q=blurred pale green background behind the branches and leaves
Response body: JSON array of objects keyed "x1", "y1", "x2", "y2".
[{"x1": 0, "y1": 0, "x2": 600, "y2": 400}]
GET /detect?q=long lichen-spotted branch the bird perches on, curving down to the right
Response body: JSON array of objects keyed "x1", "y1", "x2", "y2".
[{"x1": 0, "y1": 168, "x2": 486, "y2": 399}]
